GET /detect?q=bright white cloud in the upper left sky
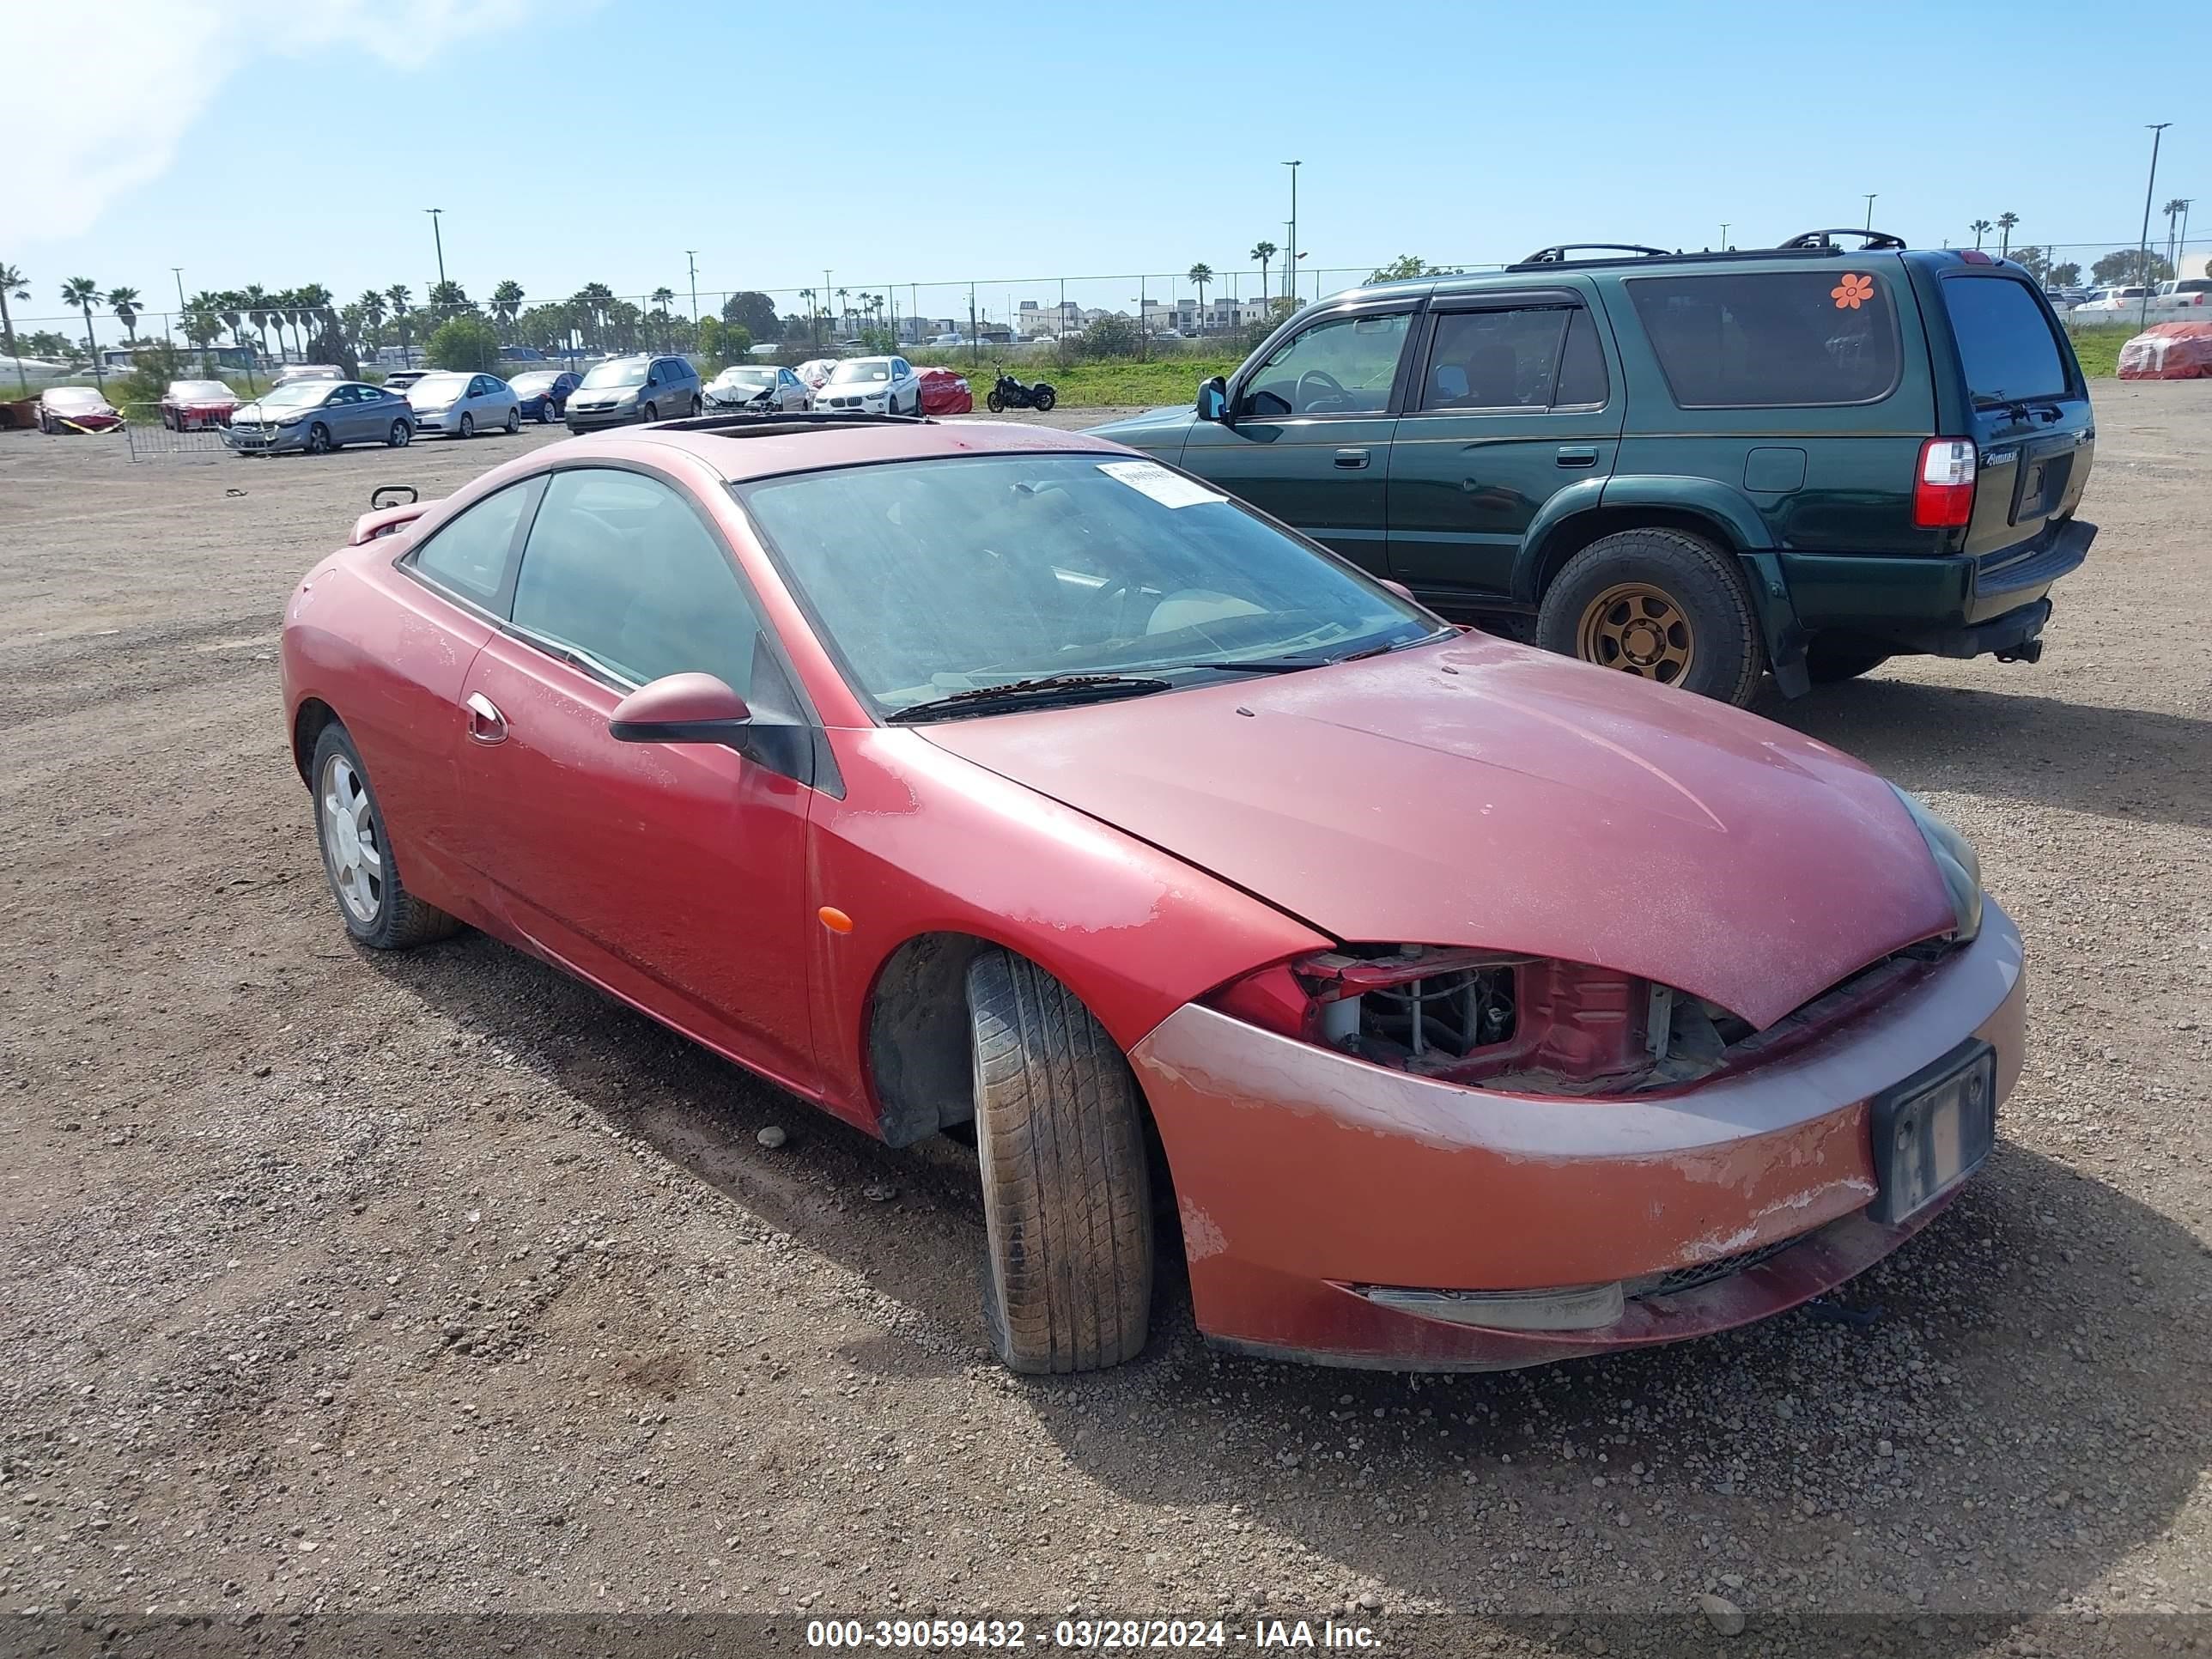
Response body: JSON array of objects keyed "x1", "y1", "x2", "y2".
[{"x1": 4, "y1": 0, "x2": 531, "y2": 248}]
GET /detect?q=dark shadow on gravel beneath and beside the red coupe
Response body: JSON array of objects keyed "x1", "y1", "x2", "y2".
[{"x1": 365, "y1": 936, "x2": 2212, "y2": 1652}]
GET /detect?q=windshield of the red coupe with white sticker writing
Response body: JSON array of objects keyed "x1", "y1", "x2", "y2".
[{"x1": 737, "y1": 453, "x2": 1437, "y2": 714}]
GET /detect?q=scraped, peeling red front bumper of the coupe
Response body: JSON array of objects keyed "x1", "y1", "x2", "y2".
[{"x1": 1130, "y1": 905, "x2": 2027, "y2": 1371}]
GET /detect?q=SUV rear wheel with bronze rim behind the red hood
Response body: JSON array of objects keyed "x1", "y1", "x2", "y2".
[{"x1": 1535, "y1": 529, "x2": 1765, "y2": 708}]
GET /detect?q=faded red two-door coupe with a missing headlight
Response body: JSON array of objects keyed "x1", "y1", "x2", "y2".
[{"x1": 283, "y1": 416, "x2": 2024, "y2": 1371}]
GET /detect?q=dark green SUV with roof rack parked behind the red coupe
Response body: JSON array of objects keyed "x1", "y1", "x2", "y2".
[{"x1": 1097, "y1": 230, "x2": 2097, "y2": 703}]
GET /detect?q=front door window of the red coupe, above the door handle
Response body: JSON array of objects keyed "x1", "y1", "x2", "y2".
[{"x1": 514, "y1": 467, "x2": 759, "y2": 696}]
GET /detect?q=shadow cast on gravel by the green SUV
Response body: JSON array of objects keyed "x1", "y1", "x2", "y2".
[{"x1": 1756, "y1": 677, "x2": 2212, "y2": 830}]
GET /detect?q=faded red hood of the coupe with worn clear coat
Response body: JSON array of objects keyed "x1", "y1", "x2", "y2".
[{"x1": 914, "y1": 635, "x2": 1954, "y2": 1029}]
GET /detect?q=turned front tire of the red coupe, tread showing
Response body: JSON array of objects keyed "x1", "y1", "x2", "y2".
[{"x1": 967, "y1": 949, "x2": 1152, "y2": 1376}]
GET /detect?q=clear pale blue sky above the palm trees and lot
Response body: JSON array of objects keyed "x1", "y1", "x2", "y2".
[{"x1": 0, "y1": 0, "x2": 2212, "y2": 327}]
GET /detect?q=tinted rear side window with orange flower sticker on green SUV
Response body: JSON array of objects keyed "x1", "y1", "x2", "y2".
[{"x1": 1626, "y1": 270, "x2": 1898, "y2": 410}]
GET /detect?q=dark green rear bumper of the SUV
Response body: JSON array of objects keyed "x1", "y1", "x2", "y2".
[{"x1": 1771, "y1": 518, "x2": 2097, "y2": 657}]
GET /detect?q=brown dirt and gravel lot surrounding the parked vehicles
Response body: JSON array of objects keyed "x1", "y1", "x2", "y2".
[{"x1": 0, "y1": 396, "x2": 2212, "y2": 1655}]
